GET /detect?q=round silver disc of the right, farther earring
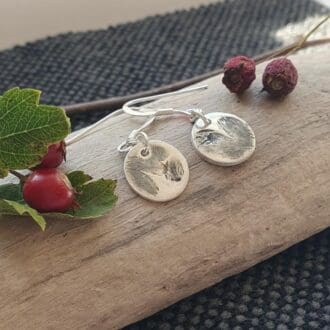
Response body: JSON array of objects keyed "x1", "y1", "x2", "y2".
[{"x1": 192, "y1": 112, "x2": 256, "y2": 166}]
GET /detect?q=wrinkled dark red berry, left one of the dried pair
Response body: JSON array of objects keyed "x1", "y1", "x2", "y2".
[{"x1": 222, "y1": 55, "x2": 256, "y2": 93}]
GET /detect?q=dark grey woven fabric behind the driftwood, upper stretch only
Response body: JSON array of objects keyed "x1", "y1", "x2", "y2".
[{"x1": 0, "y1": 0, "x2": 325, "y2": 129}]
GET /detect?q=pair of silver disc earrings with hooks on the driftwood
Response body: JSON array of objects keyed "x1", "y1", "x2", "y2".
[{"x1": 118, "y1": 86, "x2": 256, "y2": 202}]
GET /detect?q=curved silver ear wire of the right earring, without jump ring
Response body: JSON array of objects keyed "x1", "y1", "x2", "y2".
[{"x1": 123, "y1": 85, "x2": 208, "y2": 117}]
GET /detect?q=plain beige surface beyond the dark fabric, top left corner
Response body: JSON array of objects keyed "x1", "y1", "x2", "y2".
[{"x1": 0, "y1": 0, "x2": 220, "y2": 49}]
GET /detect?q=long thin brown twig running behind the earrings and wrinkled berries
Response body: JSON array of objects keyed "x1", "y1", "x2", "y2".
[{"x1": 62, "y1": 38, "x2": 330, "y2": 115}]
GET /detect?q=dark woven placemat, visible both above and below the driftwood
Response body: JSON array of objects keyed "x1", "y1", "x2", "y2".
[{"x1": 0, "y1": 0, "x2": 330, "y2": 330}]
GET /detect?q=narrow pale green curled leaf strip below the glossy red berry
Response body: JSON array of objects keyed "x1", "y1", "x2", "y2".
[{"x1": 0, "y1": 199, "x2": 46, "y2": 230}]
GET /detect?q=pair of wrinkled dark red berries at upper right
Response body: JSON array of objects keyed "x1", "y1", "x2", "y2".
[{"x1": 222, "y1": 56, "x2": 298, "y2": 97}]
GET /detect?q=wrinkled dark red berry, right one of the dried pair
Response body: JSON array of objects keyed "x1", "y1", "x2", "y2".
[{"x1": 262, "y1": 57, "x2": 298, "y2": 96}]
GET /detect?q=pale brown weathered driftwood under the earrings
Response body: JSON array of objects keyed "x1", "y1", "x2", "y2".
[{"x1": 0, "y1": 54, "x2": 330, "y2": 329}]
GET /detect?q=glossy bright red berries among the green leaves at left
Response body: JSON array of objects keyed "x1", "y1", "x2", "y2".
[{"x1": 22, "y1": 141, "x2": 79, "y2": 212}]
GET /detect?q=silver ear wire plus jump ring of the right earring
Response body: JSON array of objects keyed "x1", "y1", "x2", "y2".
[{"x1": 123, "y1": 85, "x2": 210, "y2": 127}]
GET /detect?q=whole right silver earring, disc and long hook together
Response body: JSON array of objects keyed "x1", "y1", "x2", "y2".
[{"x1": 123, "y1": 86, "x2": 256, "y2": 166}]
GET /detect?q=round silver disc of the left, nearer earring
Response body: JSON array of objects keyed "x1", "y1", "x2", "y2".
[{"x1": 124, "y1": 140, "x2": 189, "y2": 202}]
